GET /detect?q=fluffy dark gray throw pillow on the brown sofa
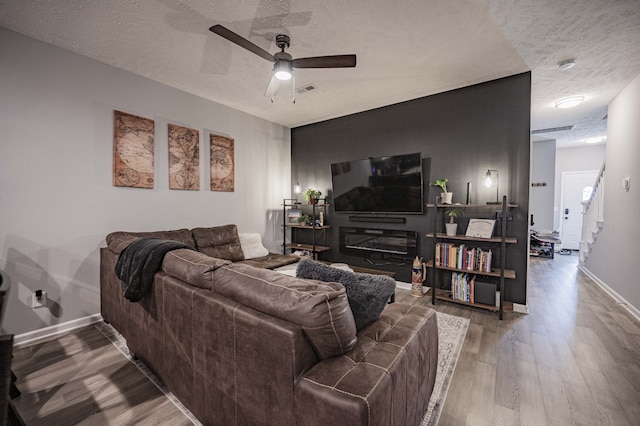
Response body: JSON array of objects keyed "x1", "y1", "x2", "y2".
[{"x1": 296, "y1": 259, "x2": 396, "y2": 330}]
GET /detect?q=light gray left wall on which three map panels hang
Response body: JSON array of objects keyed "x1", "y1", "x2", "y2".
[{"x1": 0, "y1": 28, "x2": 290, "y2": 333}]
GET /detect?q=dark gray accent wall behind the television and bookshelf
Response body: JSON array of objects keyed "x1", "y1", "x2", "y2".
[{"x1": 291, "y1": 72, "x2": 531, "y2": 304}]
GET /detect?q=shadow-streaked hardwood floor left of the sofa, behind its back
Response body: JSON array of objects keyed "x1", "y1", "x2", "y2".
[{"x1": 12, "y1": 326, "x2": 192, "y2": 426}]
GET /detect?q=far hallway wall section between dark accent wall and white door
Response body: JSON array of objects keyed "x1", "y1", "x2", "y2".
[{"x1": 529, "y1": 140, "x2": 556, "y2": 231}]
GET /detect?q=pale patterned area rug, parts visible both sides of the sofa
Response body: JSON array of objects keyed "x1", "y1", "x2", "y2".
[{"x1": 96, "y1": 312, "x2": 469, "y2": 426}]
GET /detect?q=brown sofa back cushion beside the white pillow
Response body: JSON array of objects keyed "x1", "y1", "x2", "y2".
[{"x1": 191, "y1": 225, "x2": 244, "y2": 262}]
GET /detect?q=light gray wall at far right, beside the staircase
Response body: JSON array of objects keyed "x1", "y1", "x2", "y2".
[{"x1": 585, "y1": 75, "x2": 640, "y2": 311}]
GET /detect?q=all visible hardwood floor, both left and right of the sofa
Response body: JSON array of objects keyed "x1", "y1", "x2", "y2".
[{"x1": 13, "y1": 251, "x2": 640, "y2": 426}]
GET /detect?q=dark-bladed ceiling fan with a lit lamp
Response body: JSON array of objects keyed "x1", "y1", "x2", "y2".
[{"x1": 209, "y1": 25, "x2": 356, "y2": 80}]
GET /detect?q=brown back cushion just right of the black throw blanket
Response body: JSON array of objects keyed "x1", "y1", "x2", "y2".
[{"x1": 162, "y1": 249, "x2": 231, "y2": 290}]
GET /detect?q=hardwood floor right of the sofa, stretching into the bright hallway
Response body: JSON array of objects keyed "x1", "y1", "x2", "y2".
[{"x1": 397, "y1": 252, "x2": 640, "y2": 426}]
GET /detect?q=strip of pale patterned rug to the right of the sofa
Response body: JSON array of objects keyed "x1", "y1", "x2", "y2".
[{"x1": 420, "y1": 312, "x2": 469, "y2": 426}]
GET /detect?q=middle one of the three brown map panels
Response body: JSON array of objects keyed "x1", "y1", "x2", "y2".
[{"x1": 169, "y1": 124, "x2": 200, "y2": 191}]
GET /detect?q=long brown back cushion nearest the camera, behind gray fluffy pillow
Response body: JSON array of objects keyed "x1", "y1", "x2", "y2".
[{"x1": 213, "y1": 263, "x2": 356, "y2": 359}]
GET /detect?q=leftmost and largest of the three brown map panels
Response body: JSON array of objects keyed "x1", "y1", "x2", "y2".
[{"x1": 113, "y1": 110, "x2": 154, "y2": 188}]
